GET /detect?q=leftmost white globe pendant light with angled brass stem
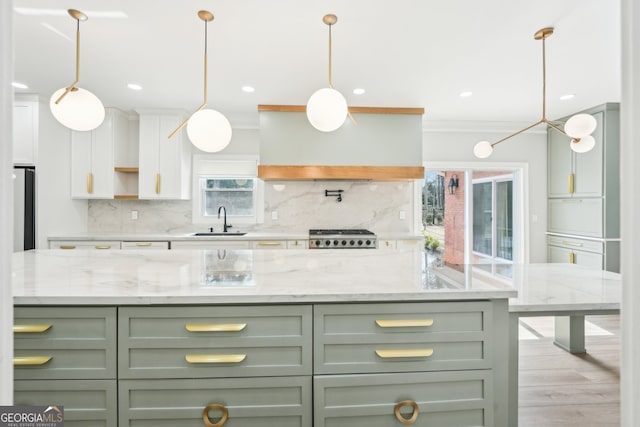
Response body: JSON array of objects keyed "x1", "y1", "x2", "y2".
[{"x1": 49, "y1": 9, "x2": 105, "y2": 131}]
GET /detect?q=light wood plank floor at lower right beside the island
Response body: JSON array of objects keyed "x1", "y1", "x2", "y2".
[{"x1": 518, "y1": 315, "x2": 620, "y2": 427}]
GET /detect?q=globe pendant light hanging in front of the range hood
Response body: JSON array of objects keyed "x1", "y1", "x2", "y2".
[{"x1": 307, "y1": 14, "x2": 349, "y2": 132}]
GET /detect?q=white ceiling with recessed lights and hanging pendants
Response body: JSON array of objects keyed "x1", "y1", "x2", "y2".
[{"x1": 13, "y1": 0, "x2": 620, "y2": 126}]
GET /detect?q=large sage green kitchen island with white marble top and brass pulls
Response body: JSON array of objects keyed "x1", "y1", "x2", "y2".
[{"x1": 13, "y1": 249, "x2": 516, "y2": 427}]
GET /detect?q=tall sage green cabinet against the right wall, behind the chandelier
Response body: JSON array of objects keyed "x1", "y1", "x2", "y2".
[{"x1": 547, "y1": 103, "x2": 620, "y2": 272}]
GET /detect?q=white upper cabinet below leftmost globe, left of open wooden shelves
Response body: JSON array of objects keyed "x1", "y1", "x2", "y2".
[{"x1": 71, "y1": 108, "x2": 128, "y2": 199}]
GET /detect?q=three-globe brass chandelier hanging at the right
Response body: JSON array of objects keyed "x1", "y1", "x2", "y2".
[{"x1": 473, "y1": 27, "x2": 597, "y2": 159}]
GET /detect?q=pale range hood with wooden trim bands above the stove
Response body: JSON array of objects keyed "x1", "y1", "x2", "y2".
[{"x1": 258, "y1": 105, "x2": 424, "y2": 181}]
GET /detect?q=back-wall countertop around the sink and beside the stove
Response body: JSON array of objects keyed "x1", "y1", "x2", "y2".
[{"x1": 48, "y1": 232, "x2": 424, "y2": 242}]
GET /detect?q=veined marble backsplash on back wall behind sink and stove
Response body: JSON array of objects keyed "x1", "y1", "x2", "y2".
[{"x1": 88, "y1": 181, "x2": 415, "y2": 234}]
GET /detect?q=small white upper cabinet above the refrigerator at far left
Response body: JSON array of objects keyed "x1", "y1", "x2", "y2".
[{"x1": 13, "y1": 96, "x2": 38, "y2": 165}]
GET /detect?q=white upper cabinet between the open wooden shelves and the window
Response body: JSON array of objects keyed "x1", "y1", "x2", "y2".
[{"x1": 137, "y1": 110, "x2": 191, "y2": 200}]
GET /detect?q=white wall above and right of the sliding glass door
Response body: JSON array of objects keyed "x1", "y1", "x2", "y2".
[{"x1": 422, "y1": 123, "x2": 547, "y2": 262}]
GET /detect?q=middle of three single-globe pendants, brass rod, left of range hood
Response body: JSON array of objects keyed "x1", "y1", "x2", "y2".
[{"x1": 169, "y1": 10, "x2": 232, "y2": 153}]
